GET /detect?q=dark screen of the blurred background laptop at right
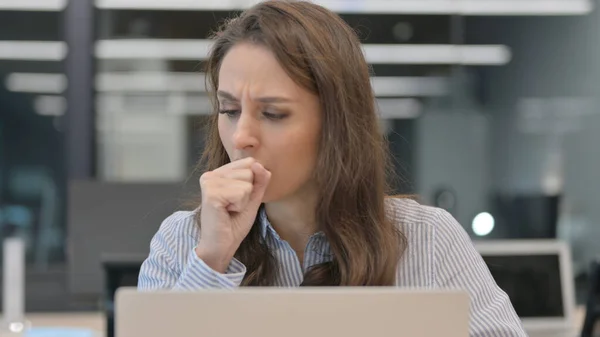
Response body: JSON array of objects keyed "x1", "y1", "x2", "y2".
[{"x1": 483, "y1": 254, "x2": 565, "y2": 318}]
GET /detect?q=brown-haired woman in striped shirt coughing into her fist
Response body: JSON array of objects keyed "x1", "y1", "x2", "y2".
[{"x1": 139, "y1": 1, "x2": 525, "y2": 336}]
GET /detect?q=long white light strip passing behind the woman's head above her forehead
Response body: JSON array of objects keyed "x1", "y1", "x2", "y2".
[{"x1": 95, "y1": 39, "x2": 511, "y2": 65}]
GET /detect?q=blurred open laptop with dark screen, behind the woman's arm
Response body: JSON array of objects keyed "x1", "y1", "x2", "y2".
[{"x1": 475, "y1": 240, "x2": 577, "y2": 337}]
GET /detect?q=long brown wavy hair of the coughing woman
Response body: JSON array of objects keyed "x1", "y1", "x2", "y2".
[{"x1": 197, "y1": 1, "x2": 406, "y2": 286}]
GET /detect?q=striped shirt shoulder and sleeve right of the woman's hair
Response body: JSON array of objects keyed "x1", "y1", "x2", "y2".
[{"x1": 389, "y1": 199, "x2": 526, "y2": 336}]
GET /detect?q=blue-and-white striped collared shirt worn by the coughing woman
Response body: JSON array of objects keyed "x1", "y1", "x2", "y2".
[{"x1": 138, "y1": 199, "x2": 527, "y2": 337}]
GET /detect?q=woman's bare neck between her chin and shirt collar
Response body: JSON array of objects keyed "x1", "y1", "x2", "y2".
[{"x1": 265, "y1": 185, "x2": 318, "y2": 261}]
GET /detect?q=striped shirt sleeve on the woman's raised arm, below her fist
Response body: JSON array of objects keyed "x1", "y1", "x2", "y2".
[{"x1": 138, "y1": 212, "x2": 246, "y2": 291}]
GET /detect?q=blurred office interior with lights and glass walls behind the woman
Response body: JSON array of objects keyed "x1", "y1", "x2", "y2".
[{"x1": 0, "y1": 0, "x2": 600, "y2": 311}]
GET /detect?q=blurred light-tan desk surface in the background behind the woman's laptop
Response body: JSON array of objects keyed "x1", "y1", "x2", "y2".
[{"x1": 2, "y1": 307, "x2": 585, "y2": 336}]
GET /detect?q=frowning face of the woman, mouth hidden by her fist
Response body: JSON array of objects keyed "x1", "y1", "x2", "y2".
[{"x1": 217, "y1": 43, "x2": 321, "y2": 202}]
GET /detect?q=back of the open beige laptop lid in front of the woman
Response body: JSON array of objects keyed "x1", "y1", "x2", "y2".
[{"x1": 115, "y1": 287, "x2": 469, "y2": 337}]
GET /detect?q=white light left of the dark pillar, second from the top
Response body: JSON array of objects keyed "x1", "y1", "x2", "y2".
[{"x1": 0, "y1": 41, "x2": 67, "y2": 61}]
